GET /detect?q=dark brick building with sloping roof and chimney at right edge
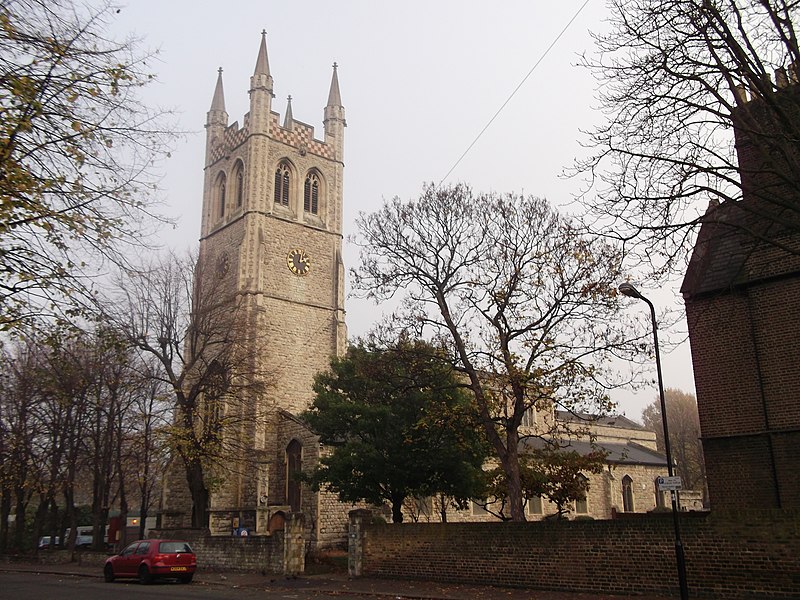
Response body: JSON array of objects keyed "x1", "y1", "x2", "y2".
[{"x1": 681, "y1": 79, "x2": 800, "y2": 509}]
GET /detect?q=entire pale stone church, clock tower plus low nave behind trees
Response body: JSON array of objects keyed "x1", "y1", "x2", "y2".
[{"x1": 161, "y1": 33, "x2": 680, "y2": 547}]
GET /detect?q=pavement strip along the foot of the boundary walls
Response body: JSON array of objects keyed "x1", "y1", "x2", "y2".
[{"x1": 0, "y1": 562, "x2": 666, "y2": 600}]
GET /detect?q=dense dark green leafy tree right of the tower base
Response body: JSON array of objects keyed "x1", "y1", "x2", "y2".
[{"x1": 304, "y1": 340, "x2": 486, "y2": 523}]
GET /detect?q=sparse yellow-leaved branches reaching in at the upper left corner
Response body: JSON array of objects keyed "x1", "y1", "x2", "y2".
[{"x1": 0, "y1": 0, "x2": 171, "y2": 329}]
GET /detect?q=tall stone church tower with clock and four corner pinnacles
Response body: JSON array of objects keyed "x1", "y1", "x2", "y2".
[{"x1": 165, "y1": 32, "x2": 347, "y2": 535}]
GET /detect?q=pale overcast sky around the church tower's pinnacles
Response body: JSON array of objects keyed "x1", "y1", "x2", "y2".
[{"x1": 109, "y1": 0, "x2": 694, "y2": 419}]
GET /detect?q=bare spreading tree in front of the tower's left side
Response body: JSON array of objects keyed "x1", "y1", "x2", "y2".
[{"x1": 109, "y1": 255, "x2": 270, "y2": 527}]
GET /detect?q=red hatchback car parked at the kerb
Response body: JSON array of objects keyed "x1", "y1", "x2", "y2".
[{"x1": 103, "y1": 540, "x2": 197, "y2": 583}]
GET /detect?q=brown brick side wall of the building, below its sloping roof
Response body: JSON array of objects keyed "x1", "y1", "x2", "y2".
[{"x1": 686, "y1": 274, "x2": 800, "y2": 508}]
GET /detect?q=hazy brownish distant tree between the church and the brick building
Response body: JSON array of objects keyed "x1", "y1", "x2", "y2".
[{"x1": 642, "y1": 388, "x2": 706, "y2": 494}]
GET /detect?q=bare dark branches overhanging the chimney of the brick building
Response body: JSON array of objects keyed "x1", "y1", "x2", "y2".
[{"x1": 576, "y1": 0, "x2": 800, "y2": 276}]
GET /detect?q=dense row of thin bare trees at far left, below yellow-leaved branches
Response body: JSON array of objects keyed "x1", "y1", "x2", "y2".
[{"x1": 0, "y1": 325, "x2": 170, "y2": 549}]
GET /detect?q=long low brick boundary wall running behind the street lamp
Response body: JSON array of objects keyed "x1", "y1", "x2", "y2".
[{"x1": 350, "y1": 511, "x2": 800, "y2": 599}]
